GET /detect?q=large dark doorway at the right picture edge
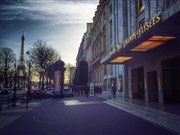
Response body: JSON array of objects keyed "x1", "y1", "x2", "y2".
[{"x1": 162, "y1": 57, "x2": 180, "y2": 103}]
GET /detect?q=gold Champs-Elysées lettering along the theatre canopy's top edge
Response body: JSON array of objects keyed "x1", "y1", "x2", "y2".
[{"x1": 109, "y1": 14, "x2": 161, "y2": 56}]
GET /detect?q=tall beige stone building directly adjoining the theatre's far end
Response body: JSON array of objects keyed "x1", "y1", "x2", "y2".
[{"x1": 91, "y1": 0, "x2": 108, "y2": 90}]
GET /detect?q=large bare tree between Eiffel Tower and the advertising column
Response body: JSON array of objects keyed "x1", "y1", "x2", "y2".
[{"x1": 29, "y1": 40, "x2": 60, "y2": 89}]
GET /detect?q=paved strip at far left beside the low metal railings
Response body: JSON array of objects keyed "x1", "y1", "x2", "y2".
[{"x1": 0, "y1": 100, "x2": 42, "y2": 128}]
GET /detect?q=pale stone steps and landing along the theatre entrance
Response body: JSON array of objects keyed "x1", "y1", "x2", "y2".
[{"x1": 98, "y1": 95, "x2": 180, "y2": 134}]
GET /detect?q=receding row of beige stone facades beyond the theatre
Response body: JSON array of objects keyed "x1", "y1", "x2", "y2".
[{"x1": 76, "y1": 0, "x2": 111, "y2": 92}]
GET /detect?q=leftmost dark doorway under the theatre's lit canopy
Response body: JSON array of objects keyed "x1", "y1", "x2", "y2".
[{"x1": 131, "y1": 67, "x2": 145, "y2": 99}]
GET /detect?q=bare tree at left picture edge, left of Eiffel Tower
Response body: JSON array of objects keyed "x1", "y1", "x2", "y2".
[{"x1": 0, "y1": 47, "x2": 16, "y2": 87}]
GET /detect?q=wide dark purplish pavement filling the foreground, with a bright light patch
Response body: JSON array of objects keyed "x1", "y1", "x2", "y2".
[{"x1": 0, "y1": 96, "x2": 175, "y2": 135}]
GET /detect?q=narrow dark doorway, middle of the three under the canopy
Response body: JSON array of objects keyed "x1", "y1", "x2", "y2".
[{"x1": 147, "y1": 71, "x2": 158, "y2": 102}]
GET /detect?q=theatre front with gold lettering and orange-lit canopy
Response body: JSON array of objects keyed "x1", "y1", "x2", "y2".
[{"x1": 101, "y1": 0, "x2": 180, "y2": 103}]
